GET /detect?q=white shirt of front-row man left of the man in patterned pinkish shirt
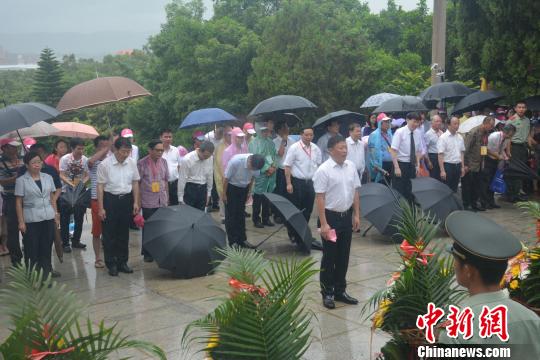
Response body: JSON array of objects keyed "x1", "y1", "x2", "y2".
[{"x1": 97, "y1": 155, "x2": 141, "y2": 195}]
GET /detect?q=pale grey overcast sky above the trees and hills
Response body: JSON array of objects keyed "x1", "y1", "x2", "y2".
[{"x1": 0, "y1": 0, "x2": 432, "y2": 34}]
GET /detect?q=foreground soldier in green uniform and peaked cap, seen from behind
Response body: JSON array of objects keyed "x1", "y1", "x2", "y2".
[{"x1": 439, "y1": 211, "x2": 540, "y2": 360}]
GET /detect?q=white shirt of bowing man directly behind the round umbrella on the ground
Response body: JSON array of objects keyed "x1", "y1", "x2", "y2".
[{"x1": 178, "y1": 150, "x2": 214, "y2": 202}]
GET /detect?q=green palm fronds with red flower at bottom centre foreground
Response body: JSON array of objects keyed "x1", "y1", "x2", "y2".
[{"x1": 182, "y1": 248, "x2": 317, "y2": 360}]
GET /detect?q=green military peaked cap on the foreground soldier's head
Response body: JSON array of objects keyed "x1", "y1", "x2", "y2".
[{"x1": 445, "y1": 211, "x2": 521, "y2": 261}]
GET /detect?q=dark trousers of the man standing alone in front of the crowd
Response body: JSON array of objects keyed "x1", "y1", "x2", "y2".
[{"x1": 320, "y1": 209, "x2": 352, "y2": 295}]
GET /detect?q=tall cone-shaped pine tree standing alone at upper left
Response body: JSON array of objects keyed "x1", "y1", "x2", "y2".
[{"x1": 32, "y1": 48, "x2": 64, "y2": 107}]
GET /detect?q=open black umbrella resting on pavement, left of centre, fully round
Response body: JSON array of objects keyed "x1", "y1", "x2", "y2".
[{"x1": 143, "y1": 205, "x2": 226, "y2": 279}]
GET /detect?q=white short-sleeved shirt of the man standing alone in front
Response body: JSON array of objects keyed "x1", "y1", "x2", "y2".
[{"x1": 313, "y1": 158, "x2": 361, "y2": 212}]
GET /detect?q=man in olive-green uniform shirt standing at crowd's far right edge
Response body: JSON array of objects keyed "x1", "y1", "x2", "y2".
[{"x1": 506, "y1": 101, "x2": 536, "y2": 202}]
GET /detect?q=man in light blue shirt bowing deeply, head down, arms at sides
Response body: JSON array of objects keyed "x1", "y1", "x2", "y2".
[{"x1": 222, "y1": 154, "x2": 266, "y2": 248}]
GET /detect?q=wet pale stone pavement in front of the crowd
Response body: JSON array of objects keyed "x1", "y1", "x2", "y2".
[{"x1": 0, "y1": 197, "x2": 535, "y2": 360}]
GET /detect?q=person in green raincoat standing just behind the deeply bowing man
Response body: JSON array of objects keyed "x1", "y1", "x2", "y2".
[{"x1": 248, "y1": 120, "x2": 277, "y2": 228}]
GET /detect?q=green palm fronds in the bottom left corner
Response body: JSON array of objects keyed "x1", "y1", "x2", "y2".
[{"x1": 0, "y1": 264, "x2": 166, "y2": 360}]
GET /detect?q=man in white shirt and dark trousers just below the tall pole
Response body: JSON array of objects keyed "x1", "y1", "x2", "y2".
[{"x1": 437, "y1": 116, "x2": 465, "y2": 192}]
